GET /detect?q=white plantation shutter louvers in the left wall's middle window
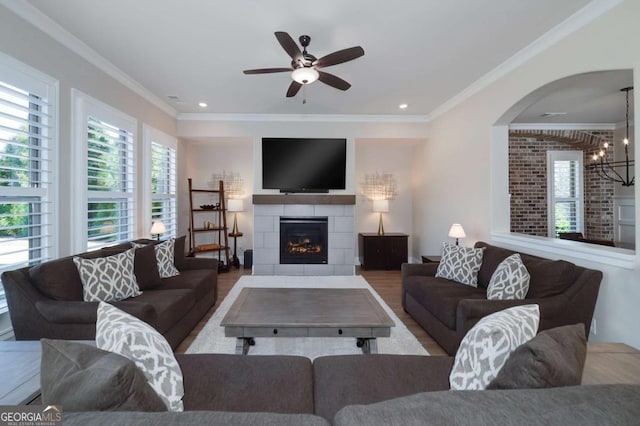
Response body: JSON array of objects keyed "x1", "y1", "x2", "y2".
[{"x1": 87, "y1": 116, "x2": 136, "y2": 250}]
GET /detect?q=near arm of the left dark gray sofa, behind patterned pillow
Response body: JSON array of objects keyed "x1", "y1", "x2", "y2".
[{"x1": 35, "y1": 300, "x2": 158, "y2": 328}]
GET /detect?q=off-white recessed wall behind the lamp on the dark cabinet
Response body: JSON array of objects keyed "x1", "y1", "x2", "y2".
[{"x1": 355, "y1": 139, "x2": 423, "y2": 260}]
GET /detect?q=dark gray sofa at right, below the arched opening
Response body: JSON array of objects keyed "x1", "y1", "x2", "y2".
[{"x1": 402, "y1": 242, "x2": 602, "y2": 355}]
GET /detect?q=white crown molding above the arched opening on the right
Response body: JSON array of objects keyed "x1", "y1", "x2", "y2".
[{"x1": 429, "y1": 0, "x2": 624, "y2": 120}]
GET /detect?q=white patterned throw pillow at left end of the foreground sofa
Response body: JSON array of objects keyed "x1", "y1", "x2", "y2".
[{"x1": 96, "y1": 302, "x2": 184, "y2": 411}]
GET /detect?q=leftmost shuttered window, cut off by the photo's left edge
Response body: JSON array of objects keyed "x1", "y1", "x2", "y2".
[{"x1": 0, "y1": 56, "x2": 57, "y2": 312}]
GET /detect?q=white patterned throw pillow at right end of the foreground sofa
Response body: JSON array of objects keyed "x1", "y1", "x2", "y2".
[{"x1": 449, "y1": 305, "x2": 540, "y2": 390}]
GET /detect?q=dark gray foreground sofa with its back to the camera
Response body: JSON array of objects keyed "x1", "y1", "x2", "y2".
[{"x1": 50, "y1": 354, "x2": 640, "y2": 426}]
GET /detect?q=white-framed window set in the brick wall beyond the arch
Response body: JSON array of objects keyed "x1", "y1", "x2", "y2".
[{"x1": 547, "y1": 151, "x2": 584, "y2": 238}]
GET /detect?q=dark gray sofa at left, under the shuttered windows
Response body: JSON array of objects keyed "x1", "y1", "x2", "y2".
[{"x1": 2, "y1": 237, "x2": 218, "y2": 349}]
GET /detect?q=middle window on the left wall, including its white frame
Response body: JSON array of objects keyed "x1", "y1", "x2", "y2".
[{"x1": 74, "y1": 91, "x2": 136, "y2": 251}]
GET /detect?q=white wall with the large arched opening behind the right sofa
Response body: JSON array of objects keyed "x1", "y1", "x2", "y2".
[{"x1": 414, "y1": 0, "x2": 640, "y2": 348}]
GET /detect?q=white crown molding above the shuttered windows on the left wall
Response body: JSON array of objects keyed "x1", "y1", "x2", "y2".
[{"x1": 0, "y1": 0, "x2": 177, "y2": 118}]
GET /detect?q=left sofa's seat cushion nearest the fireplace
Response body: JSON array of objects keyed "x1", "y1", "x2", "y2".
[{"x1": 132, "y1": 290, "x2": 197, "y2": 334}]
